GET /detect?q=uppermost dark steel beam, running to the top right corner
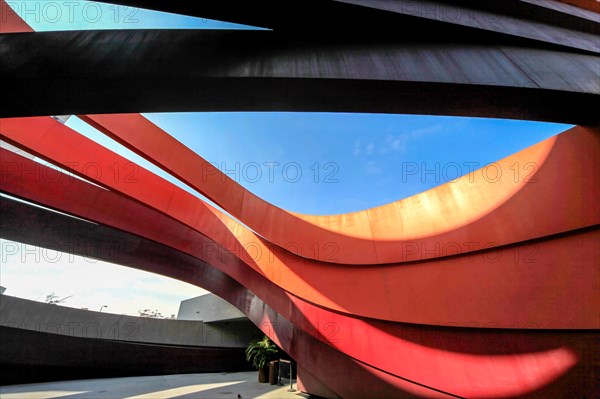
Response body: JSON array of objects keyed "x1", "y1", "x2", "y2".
[{"x1": 96, "y1": 0, "x2": 600, "y2": 53}]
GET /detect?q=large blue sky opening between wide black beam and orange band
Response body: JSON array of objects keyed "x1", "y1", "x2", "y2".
[{"x1": 139, "y1": 112, "x2": 569, "y2": 214}]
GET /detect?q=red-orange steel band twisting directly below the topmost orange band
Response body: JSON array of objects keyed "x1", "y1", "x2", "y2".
[{"x1": 0, "y1": 118, "x2": 600, "y2": 328}]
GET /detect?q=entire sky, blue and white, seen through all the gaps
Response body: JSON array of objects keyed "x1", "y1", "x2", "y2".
[{"x1": 0, "y1": 1, "x2": 569, "y2": 315}]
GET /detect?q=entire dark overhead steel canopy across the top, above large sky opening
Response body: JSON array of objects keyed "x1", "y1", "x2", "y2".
[{"x1": 0, "y1": 1, "x2": 600, "y2": 125}]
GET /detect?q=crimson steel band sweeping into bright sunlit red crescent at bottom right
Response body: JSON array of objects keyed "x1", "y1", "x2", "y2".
[{"x1": 2, "y1": 155, "x2": 599, "y2": 397}]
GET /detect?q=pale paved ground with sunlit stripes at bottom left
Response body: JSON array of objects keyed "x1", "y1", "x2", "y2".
[{"x1": 0, "y1": 371, "x2": 309, "y2": 399}]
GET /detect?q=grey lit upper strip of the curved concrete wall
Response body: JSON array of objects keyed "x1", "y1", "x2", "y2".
[{"x1": 0, "y1": 295, "x2": 262, "y2": 348}]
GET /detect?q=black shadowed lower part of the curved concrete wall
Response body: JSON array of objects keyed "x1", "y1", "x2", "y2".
[{"x1": 0, "y1": 326, "x2": 252, "y2": 385}]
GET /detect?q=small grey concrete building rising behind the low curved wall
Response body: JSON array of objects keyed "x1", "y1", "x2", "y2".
[{"x1": 177, "y1": 294, "x2": 248, "y2": 323}]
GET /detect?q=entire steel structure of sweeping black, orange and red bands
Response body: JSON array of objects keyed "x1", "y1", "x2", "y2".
[{"x1": 0, "y1": 0, "x2": 600, "y2": 398}]
